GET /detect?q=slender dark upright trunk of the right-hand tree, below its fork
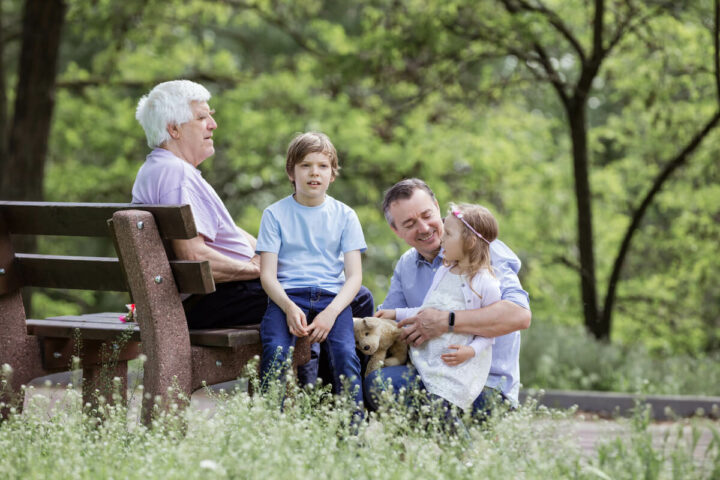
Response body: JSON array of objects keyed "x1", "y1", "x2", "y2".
[{"x1": 567, "y1": 97, "x2": 610, "y2": 339}]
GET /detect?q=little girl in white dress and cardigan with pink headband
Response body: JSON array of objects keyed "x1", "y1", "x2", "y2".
[{"x1": 378, "y1": 204, "x2": 500, "y2": 410}]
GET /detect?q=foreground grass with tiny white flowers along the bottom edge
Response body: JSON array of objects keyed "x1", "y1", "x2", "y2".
[{"x1": 0, "y1": 364, "x2": 720, "y2": 480}]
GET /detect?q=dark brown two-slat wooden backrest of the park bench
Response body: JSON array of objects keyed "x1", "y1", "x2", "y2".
[{"x1": 0, "y1": 201, "x2": 215, "y2": 296}]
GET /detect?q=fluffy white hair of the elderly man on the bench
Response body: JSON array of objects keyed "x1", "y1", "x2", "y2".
[{"x1": 135, "y1": 80, "x2": 210, "y2": 148}]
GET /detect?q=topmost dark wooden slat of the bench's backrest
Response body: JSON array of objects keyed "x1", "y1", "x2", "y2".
[{"x1": 0, "y1": 201, "x2": 198, "y2": 240}]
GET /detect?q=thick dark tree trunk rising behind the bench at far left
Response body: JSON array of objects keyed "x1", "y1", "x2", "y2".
[{"x1": 0, "y1": 0, "x2": 65, "y2": 200}]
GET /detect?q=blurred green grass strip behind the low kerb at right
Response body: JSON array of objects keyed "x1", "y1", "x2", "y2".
[{"x1": 520, "y1": 321, "x2": 720, "y2": 396}]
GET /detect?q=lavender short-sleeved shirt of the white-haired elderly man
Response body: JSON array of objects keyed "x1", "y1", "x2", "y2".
[{"x1": 132, "y1": 148, "x2": 255, "y2": 261}]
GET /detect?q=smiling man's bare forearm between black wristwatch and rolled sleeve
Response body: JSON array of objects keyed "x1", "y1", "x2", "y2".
[{"x1": 455, "y1": 300, "x2": 532, "y2": 338}]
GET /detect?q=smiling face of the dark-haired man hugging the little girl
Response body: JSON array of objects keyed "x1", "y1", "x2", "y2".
[{"x1": 389, "y1": 189, "x2": 443, "y2": 261}]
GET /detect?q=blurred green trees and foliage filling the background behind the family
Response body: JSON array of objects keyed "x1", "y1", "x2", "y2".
[{"x1": 0, "y1": 0, "x2": 720, "y2": 354}]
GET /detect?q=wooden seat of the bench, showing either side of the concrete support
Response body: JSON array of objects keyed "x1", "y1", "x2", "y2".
[{"x1": 27, "y1": 312, "x2": 260, "y2": 347}]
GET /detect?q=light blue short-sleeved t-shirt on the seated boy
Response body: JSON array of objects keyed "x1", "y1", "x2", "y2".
[{"x1": 255, "y1": 195, "x2": 367, "y2": 293}]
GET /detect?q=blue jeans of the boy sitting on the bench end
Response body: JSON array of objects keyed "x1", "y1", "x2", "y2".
[{"x1": 260, "y1": 287, "x2": 363, "y2": 405}]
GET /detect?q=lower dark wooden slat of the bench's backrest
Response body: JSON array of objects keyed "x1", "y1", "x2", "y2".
[{"x1": 11, "y1": 253, "x2": 215, "y2": 294}]
